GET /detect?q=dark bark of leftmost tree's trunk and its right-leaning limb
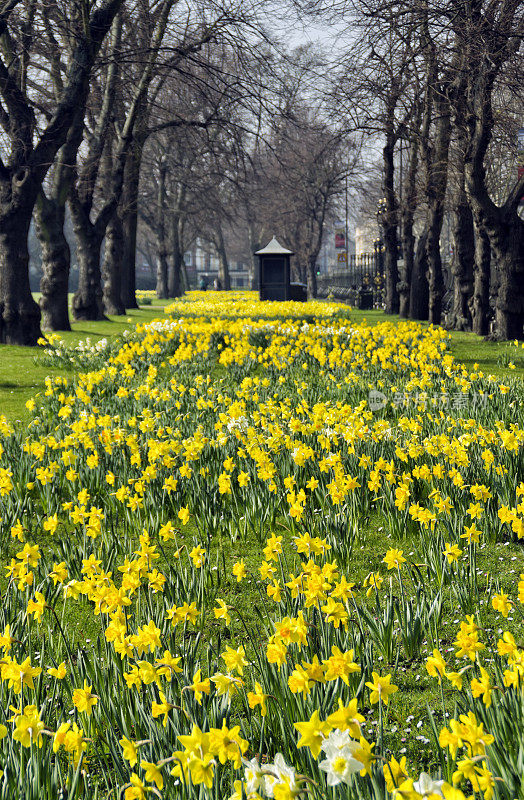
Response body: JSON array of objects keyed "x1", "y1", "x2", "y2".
[{"x1": 0, "y1": 0, "x2": 121, "y2": 345}]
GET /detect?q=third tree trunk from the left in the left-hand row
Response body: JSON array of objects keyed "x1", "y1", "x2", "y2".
[{"x1": 70, "y1": 201, "x2": 107, "y2": 320}]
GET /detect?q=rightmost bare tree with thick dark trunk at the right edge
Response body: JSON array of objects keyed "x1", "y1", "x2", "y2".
[{"x1": 454, "y1": 0, "x2": 524, "y2": 339}]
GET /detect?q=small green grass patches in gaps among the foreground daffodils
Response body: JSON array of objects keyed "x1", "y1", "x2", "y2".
[{"x1": 15, "y1": 500, "x2": 524, "y2": 771}]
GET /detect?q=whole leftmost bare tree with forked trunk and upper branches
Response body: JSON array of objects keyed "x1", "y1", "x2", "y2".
[{"x1": 0, "y1": 0, "x2": 121, "y2": 344}]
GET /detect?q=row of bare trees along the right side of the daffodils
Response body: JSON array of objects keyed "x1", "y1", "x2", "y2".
[{"x1": 320, "y1": 0, "x2": 524, "y2": 339}]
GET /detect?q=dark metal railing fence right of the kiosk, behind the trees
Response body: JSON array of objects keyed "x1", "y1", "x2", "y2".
[{"x1": 317, "y1": 251, "x2": 384, "y2": 308}]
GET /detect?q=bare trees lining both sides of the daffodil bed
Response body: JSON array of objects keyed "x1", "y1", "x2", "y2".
[{"x1": 0, "y1": 0, "x2": 524, "y2": 345}]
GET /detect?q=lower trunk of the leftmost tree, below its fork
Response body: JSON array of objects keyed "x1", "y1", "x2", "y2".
[{"x1": 0, "y1": 203, "x2": 41, "y2": 345}]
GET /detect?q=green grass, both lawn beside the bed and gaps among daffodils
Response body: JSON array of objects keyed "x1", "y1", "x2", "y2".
[{"x1": 0, "y1": 292, "x2": 524, "y2": 788}]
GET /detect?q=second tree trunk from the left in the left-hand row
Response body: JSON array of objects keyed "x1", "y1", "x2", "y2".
[{"x1": 35, "y1": 191, "x2": 71, "y2": 331}]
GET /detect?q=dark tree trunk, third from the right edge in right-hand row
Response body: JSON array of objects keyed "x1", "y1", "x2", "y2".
[{"x1": 449, "y1": 188, "x2": 475, "y2": 331}]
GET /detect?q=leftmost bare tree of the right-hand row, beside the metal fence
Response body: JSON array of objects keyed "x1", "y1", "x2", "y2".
[{"x1": 333, "y1": 6, "x2": 420, "y2": 314}]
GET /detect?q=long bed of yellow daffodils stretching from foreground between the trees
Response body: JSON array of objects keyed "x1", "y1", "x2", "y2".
[{"x1": 0, "y1": 292, "x2": 524, "y2": 800}]
